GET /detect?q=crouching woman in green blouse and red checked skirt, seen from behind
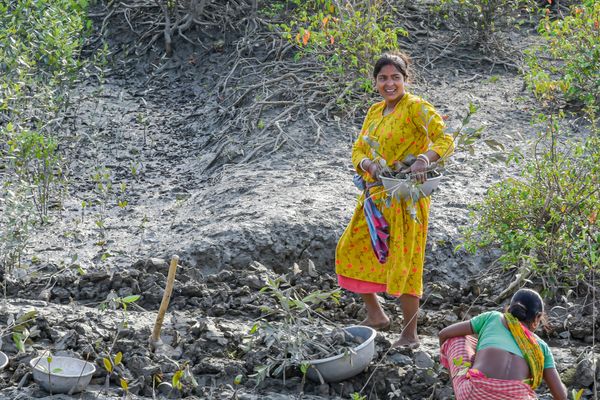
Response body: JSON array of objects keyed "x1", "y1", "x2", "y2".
[{"x1": 439, "y1": 289, "x2": 567, "y2": 400}]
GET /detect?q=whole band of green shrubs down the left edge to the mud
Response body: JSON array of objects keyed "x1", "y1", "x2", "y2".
[{"x1": 0, "y1": 0, "x2": 91, "y2": 271}]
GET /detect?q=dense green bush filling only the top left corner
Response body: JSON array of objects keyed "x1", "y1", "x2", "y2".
[{"x1": 0, "y1": 0, "x2": 90, "y2": 120}]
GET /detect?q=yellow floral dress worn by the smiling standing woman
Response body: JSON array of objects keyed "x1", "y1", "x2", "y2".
[{"x1": 335, "y1": 93, "x2": 454, "y2": 297}]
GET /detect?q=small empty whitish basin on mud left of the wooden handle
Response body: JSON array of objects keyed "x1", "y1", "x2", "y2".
[{"x1": 29, "y1": 356, "x2": 96, "y2": 393}]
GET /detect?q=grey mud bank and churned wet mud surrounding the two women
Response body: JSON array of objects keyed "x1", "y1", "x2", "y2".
[{"x1": 0, "y1": 3, "x2": 600, "y2": 399}]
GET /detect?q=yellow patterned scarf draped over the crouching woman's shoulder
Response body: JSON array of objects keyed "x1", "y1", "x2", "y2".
[{"x1": 504, "y1": 312, "x2": 544, "y2": 389}]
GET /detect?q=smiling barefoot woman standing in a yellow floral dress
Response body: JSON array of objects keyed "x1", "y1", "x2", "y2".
[{"x1": 335, "y1": 52, "x2": 454, "y2": 347}]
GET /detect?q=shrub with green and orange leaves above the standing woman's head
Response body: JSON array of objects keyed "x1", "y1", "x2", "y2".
[{"x1": 276, "y1": 0, "x2": 407, "y2": 109}]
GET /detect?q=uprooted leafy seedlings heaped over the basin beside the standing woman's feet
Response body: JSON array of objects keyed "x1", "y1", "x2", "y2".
[{"x1": 243, "y1": 276, "x2": 360, "y2": 384}]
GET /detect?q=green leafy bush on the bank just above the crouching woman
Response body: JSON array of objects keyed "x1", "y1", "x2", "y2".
[{"x1": 463, "y1": 118, "x2": 600, "y2": 291}]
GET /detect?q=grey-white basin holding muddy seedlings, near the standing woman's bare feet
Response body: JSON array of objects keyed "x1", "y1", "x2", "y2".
[{"x1": 306, "y1": 325, "x2": 377, "y2": 382}]
